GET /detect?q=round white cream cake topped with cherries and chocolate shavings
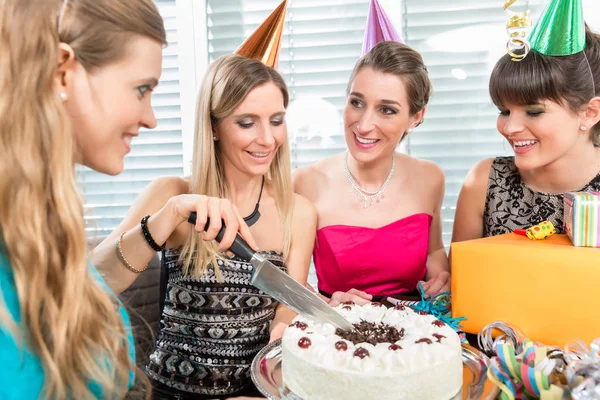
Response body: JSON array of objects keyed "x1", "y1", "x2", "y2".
[{"x1": 281, "y1": 303, "x2": 463, "y2": 400}]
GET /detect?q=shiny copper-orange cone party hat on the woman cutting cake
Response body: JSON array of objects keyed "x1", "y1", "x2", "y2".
[{"x1": 234, "y1": 0, "x2": 287, "y2": 68}]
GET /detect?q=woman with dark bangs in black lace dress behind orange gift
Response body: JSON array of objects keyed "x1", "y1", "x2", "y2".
[{"x1": 452, "y1": 28, "x2": 600, "y2": 242}]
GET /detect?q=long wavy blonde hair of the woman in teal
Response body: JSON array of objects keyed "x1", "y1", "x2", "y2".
[{"x1": 0, "y1": 0, "x2": 166, "y2": 399}]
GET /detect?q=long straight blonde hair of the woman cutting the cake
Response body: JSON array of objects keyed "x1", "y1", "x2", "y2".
[{"x1": 181, "y1": 55, "x2": 293, "y2": 281}]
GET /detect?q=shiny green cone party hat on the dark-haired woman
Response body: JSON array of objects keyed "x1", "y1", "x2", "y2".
[{"x1": 529, "y1": 0, "x2": 585, "y2": 56}]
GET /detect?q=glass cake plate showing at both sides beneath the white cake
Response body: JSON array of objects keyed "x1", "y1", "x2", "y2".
[{"x1": 251, "y1": 340, "x2": 498, "y2": 400}]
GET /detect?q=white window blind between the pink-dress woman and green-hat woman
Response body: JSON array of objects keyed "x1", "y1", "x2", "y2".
[{"x1": 402, "y1": 0, "x2": 539, "y2": 246}]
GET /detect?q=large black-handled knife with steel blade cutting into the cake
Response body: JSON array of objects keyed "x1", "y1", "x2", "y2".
[{"x1": 188, "y1": 212, "x2": 353, "y2": 331}]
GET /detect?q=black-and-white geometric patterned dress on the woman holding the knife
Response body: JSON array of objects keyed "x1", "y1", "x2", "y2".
[{"x1": 146, "y1": 249, "x2": 286, "y2": 396}]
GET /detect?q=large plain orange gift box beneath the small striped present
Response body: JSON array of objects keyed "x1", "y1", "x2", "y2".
[{"x1": 451, "y1": 233, "x2": 600, "y2": 347}]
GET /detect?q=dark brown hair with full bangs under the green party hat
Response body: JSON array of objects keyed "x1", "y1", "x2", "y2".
[{"x1": 490, "y1": 26, "x2": 600, "y2": 145}]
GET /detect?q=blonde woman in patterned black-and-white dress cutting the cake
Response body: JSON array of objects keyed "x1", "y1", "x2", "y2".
[{"x1": 92, "y1": 55, "x2": 316, "y2": 400}]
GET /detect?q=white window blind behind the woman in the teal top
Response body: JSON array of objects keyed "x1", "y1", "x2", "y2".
[{"x1": 78, "y1": 0, "x2": 183, "y2": 241}]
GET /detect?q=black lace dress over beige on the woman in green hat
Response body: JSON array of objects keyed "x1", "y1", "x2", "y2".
[{"x1": 483, "y1": 157, "x2": 600, "y2": 237}]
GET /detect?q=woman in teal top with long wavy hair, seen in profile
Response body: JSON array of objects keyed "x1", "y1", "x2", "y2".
[{"x1": 0, "y1": 0, "x2": 166, "y2": 400}]
